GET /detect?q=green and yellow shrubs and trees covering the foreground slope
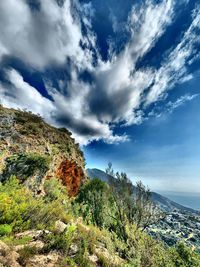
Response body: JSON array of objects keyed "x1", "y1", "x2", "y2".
[{"x1": 0, "y1": 174, "x2": 200, "y2": 267}]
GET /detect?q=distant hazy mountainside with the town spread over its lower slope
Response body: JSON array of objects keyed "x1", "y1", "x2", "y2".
[{"x1": 87, "y1": 169, "x2": 200, "y2": 251}]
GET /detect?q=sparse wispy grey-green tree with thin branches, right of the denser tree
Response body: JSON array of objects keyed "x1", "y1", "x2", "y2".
[{"x1": 106, "y1": 163, "x2": 161, "y2": 239}]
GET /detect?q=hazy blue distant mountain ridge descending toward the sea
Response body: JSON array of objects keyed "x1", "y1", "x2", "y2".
[{"x1": 86, "y1": 168, "x2": 196, "y2": 212}]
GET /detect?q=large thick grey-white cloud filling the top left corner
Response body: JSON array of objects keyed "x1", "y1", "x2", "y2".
[{"x1": 0, "y1": 0, "x2": 93, "y2": 68}]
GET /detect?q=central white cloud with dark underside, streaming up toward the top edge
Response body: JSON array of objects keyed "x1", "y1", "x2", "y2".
[{"x1": 88, "y1": 0, "x2": 173, "y2": 125}]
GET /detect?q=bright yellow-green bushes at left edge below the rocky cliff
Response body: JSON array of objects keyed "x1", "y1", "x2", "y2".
[{"x1": 0, "y1": 177, "x2": 69, "y2": 232}]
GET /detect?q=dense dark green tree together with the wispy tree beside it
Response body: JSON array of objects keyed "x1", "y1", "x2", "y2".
[{"x1": 75, "y1": 165, "x2": 162, "y2": 242}]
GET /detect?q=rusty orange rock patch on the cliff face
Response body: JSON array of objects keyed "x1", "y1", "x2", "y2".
[{"x1": 56, "y1": 159, "x2": 84, "y2": 197}]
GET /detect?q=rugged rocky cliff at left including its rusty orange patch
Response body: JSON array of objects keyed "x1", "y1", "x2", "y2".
[{"x1": 0, "y1": 106, "x2": 86, "y2": 196}]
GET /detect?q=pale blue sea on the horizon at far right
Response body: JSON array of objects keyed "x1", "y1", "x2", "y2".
[{"x1": 160, "y1": 192, "x2": 200, "y2": 211}]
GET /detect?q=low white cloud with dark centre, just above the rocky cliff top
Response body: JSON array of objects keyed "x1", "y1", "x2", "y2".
[{"x1": 0, "y1": 69, "x2": 128, "y2": 145}]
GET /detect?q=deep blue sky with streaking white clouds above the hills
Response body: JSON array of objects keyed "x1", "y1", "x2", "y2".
[{"x1": 0, "y1": 0, "x2": 200, "y2": 193}]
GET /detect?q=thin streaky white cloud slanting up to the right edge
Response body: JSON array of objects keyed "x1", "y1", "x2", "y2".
[{"x1": 146, "y1": 6, "x2": 200, "y2": 104}]
